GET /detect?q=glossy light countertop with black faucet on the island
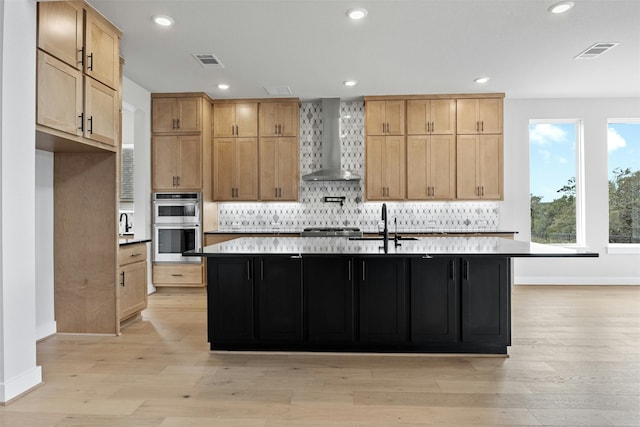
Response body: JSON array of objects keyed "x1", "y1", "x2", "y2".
[{"x1": 185, "y1": 236, "x2": 598, "y2": 257}]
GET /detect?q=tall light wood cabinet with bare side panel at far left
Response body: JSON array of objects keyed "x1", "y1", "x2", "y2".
[{"x1": 36, "y1": 1, "x2": 121, "y2": 334}]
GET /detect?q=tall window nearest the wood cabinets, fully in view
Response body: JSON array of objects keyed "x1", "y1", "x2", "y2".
[{"x1": 529, "y1": 120, "x2": 584, "y2": 244}]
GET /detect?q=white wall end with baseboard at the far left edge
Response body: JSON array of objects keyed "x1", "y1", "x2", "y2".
[{"x1": 0, "y1": 0, "x2": 42, "y2": 402}]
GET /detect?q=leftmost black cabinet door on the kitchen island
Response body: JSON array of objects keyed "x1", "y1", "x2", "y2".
[{"x1": 207, "y1": 257, "x2": 255, "y2": 347}]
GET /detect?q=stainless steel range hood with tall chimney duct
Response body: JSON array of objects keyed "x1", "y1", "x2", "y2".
[{"x1": 302, "y1": 98, "x2": 360, "y2": 181}]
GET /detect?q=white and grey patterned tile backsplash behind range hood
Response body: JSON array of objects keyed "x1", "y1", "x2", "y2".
[{"x1": 218, "y1": 101, "x2": 500, "y2": 232}]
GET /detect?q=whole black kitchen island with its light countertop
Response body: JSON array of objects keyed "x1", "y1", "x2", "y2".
[{"x1": 188, "y1": 236, "x2": 598, "y2": 354}]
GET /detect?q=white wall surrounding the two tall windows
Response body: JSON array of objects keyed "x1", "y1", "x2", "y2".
[{"x1": 500, "y1": 98, "x2": 640, "y2": 285}]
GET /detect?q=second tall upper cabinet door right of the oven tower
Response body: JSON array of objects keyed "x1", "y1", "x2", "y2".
[{"x1": 234, "y1": 138, "x2": 258, "y2": 200}]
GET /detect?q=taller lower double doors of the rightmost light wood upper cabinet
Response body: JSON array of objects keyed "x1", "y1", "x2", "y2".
[{"x1": 457, "y1": 134, "x2": 503, "y2": 200}]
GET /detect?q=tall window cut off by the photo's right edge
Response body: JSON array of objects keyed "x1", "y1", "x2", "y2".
[{"x1": 607, "y1": 119, "x2": 640, "y2": 243}]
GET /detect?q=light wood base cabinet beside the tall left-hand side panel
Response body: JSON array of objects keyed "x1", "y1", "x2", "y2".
[{"x1": 118, "y1": 243, "x2": 147, "y2": 322}]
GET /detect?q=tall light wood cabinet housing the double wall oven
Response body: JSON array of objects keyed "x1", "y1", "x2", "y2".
[{"x1": 151, "y1": 93, "x2": 216, "y2": 288}]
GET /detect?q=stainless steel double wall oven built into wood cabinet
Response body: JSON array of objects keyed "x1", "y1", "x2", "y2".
[{"x1": 153, "y1": 193, "x2": 202, "y2": 263}]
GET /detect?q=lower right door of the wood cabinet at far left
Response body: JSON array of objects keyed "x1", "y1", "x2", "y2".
[{"x1": 84, "y1": 77, "x2": 119, "y2": 146}]
